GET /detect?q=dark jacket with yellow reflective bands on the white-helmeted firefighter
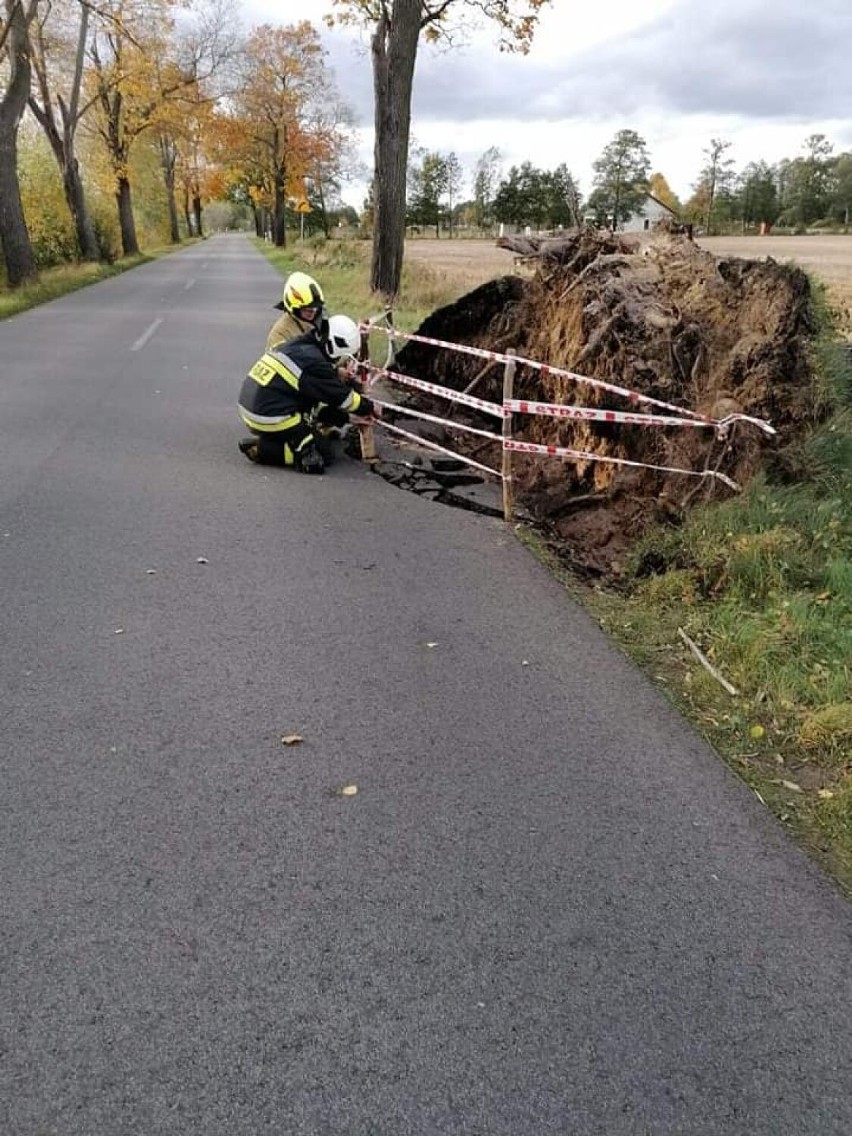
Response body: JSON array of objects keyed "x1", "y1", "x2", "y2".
[{"x1": 239, "y1": 332, "x2": 373, "y2": 433}]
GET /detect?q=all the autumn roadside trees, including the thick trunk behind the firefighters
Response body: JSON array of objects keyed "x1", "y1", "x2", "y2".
[{"x1": 0, "y1": 0, "x2": 561, "y2": 296}]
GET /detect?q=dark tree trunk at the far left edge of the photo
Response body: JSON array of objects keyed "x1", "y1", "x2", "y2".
[{"x1": 0, "y1": 0, "x2": 37, "y2": 287}]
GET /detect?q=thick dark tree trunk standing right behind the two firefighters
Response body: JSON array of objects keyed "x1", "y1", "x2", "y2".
[{"x1": 370, "y1": 0, "x2": 423, "y2": 301}]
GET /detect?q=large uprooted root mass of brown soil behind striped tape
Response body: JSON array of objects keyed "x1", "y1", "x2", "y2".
[{"x1": 394, "y1": 231, "x2": 817, "y2": 575}]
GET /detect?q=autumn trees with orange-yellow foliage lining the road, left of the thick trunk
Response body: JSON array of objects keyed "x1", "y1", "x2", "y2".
[{"x1": 0, "y1": 0, "x2": 368, "y2": 286}]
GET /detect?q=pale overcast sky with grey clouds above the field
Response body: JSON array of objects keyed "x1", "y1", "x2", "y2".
[{"x1": 243, "y1": 0, "x2": 852, "y2": 208}]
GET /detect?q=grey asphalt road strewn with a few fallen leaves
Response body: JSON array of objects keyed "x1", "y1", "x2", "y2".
[{"x1": 0, "y1": 236, "x2": 852, "y2": 1136}]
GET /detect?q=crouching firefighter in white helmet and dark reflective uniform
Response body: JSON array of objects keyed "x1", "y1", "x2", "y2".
[{"x1": 239, "y1": 316, "x2": 376, "y2": 474}]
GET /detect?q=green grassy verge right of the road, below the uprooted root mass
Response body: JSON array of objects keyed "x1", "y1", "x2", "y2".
[{"x1": 525, "y1": 310, "x2": 852, "y2": 894}]
